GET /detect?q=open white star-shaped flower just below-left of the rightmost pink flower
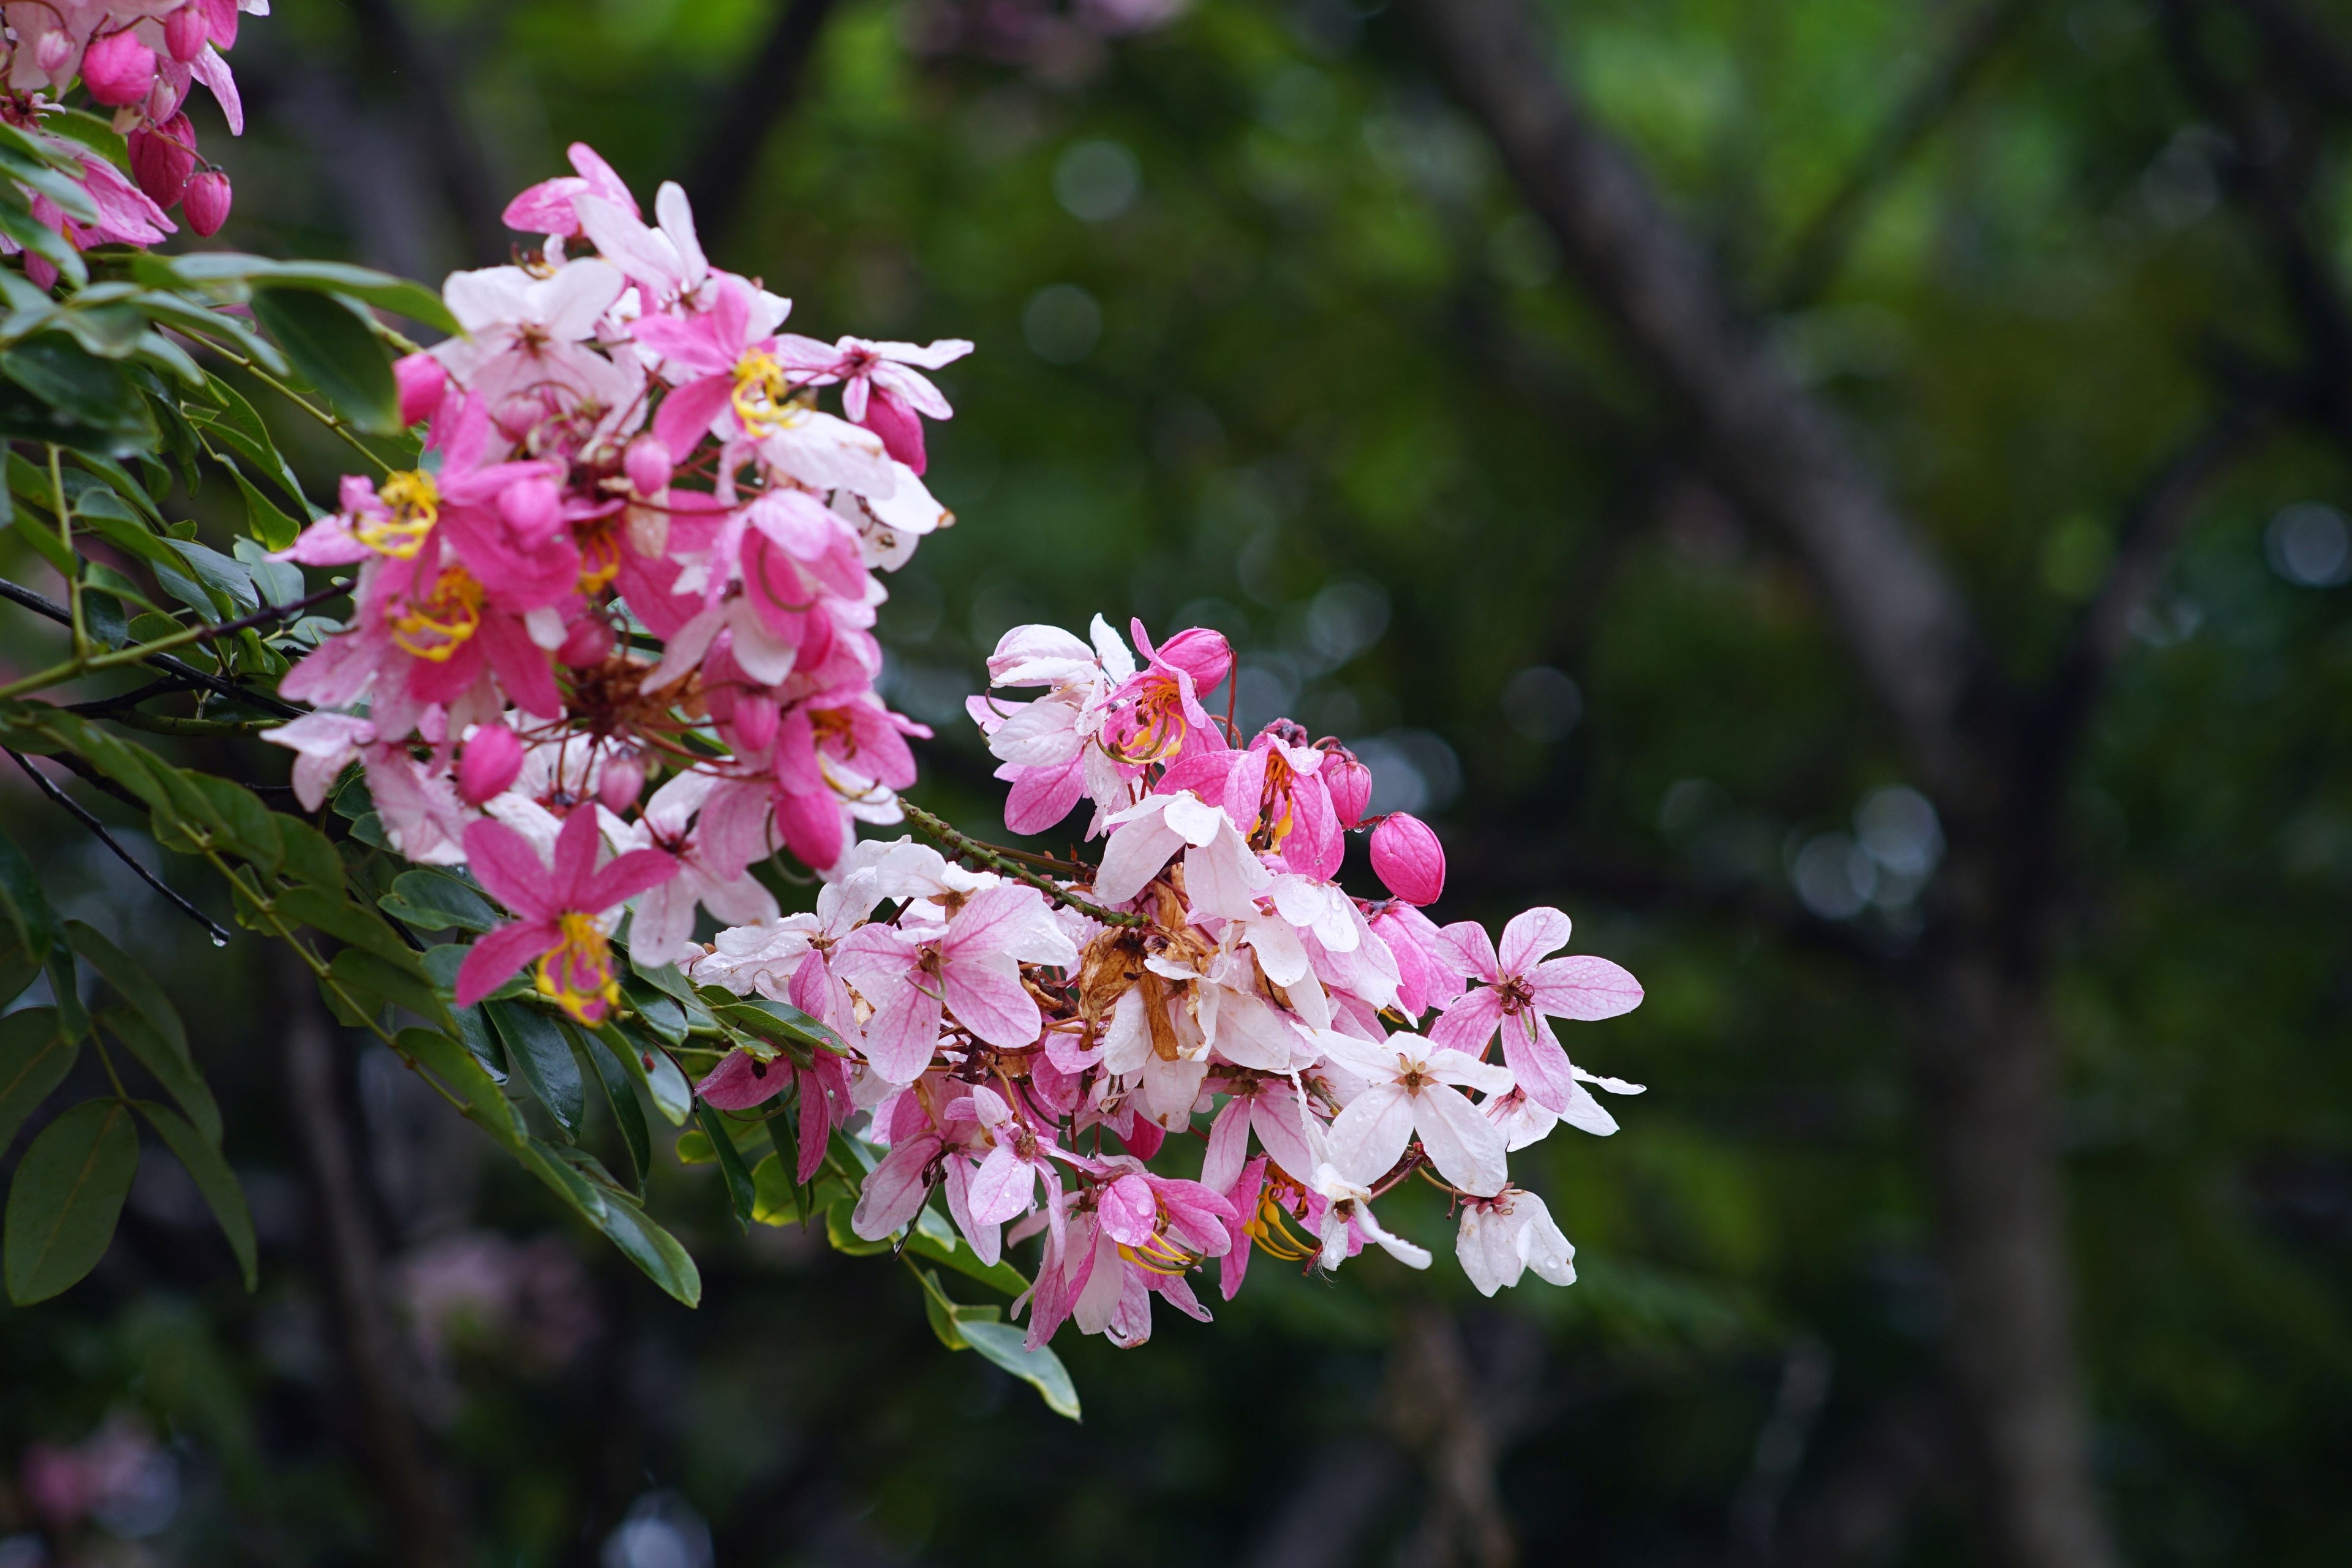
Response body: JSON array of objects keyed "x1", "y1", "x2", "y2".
[{"x1": 1319, "y1": 1032, "x2": 1510, "y2": 1197}]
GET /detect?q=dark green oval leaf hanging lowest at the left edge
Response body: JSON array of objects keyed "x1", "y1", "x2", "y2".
[{"x1": 5, "y1": 1100, "x2": 139, "y2": 1307}]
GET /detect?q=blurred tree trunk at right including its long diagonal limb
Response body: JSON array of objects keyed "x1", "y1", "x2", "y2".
[{"x1": 1414, "y1": 0, "x2": 2145, "y2": 1568}]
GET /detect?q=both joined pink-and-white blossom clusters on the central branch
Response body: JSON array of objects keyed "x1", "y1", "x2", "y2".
[{"x1": 273, "y1": 146, "x2": 1642, "y2": 1344}]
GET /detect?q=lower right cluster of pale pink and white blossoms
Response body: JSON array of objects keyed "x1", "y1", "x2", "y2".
[{"x1": 689, "y1": 618, "x2": 1642, "y2": 1344}]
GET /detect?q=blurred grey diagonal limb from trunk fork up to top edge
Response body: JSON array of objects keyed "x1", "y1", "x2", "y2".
[{"x1": 1411, "y1": 0, "x2": 1994, "y2": 799}]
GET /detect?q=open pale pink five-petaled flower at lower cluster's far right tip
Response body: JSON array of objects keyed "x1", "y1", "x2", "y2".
[{"x1": 1430, "y1": 907, "x2": 1642, "y2": 1114}]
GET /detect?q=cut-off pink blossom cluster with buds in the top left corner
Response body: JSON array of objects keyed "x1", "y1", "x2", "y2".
[{"x1": 0, "y1": 0, "x2": 271, "y2": 271}]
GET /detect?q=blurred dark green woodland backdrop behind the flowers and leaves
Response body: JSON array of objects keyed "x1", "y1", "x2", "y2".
[{"x1": 0, "y1": 0, "x2": 2352, "y2": 1568}]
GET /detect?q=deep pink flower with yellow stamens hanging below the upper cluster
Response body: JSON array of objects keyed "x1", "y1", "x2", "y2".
[{"x1": 456, "y1": 809, "x2": 677, "y2": 1025}]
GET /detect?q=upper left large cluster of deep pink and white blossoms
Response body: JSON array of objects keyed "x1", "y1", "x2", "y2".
[{"x1": 273, "y1": 146, "x2": 971, "y2": 1023}]
